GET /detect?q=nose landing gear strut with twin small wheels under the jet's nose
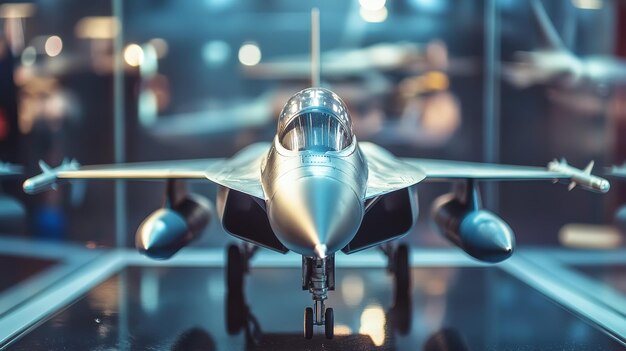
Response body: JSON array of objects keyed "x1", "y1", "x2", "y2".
[{"x1": 302, "y1": 255, "x2": 335, "y2": 339}]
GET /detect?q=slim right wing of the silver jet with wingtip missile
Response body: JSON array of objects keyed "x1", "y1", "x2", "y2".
[{"x1": 402, "y1": 158, "x2": 610, "y2": 193}]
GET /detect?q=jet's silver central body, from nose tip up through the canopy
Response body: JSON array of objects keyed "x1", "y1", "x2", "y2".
[{"x1": 261, "y1": 88, "x2": 368, "y2": 257}]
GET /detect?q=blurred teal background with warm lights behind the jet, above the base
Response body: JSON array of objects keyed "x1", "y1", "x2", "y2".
[{"x1": 0, "y1": 0, "x2": 626, "y2": 252}]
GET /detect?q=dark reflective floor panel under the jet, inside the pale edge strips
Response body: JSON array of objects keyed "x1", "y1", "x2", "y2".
[{"x1": 7, "y1": 249, "x2": 626, "y2": 351}]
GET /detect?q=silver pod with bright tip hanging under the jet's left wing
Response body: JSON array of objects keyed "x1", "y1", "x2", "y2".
[{"x1": 135, "y1": 194, "x2": 211, "y2": 260}]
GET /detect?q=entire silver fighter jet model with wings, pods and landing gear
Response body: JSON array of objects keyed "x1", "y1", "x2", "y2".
[{"x1": 24, "y1": 9, "x2": 609, "y2": 338}]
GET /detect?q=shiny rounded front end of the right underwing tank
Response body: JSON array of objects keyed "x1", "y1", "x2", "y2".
[{"x1": 460, "y1": 210, "x2": 515, "y2": 263}]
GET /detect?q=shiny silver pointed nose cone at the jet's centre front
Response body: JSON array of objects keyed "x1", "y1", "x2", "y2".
[{"x1": 268, "y1": 177, "x2": 363, "y2": 257}]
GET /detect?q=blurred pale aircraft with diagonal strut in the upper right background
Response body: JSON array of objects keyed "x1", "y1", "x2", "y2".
[{"x1": 503, "y1": 0, "x2": 626, "y2": 88}]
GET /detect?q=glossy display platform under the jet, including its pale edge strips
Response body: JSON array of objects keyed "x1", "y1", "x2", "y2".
[{"x1": 0, "y1": 241, "x2": 626, "y2": 350}]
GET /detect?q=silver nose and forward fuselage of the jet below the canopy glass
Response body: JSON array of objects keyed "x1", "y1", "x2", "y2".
[{"x1": 261, "y1": 138, "x2": 367, "y2": 256}]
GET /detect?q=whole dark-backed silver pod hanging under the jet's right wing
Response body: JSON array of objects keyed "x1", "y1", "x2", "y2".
[{"x1": 432, "y1": 192, "x2": 515, "y2": 263}]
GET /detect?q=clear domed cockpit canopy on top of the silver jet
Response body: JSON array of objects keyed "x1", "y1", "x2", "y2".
[{"x1": 278, "y1": 88, "x2": 354, "y2": 152}]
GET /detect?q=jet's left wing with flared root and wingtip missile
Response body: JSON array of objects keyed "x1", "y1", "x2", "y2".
[{"x1": 24, "y1": 143, "x2": 269, "y2": 199}]
